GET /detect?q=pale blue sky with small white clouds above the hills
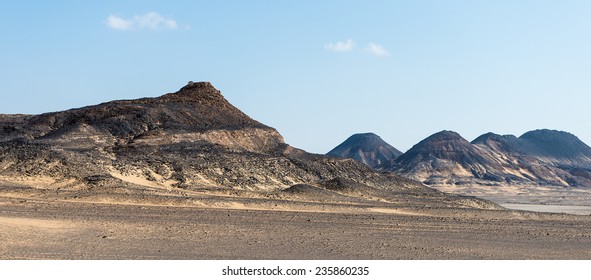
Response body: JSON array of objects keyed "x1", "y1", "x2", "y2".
[{"x1": 0, "y1": 0, "x2": 591, "y2": 153}]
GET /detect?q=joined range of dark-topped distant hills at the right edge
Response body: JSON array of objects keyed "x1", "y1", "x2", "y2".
[{"x1": 385, "y1": 130, "x2": 591, "y2": 187}]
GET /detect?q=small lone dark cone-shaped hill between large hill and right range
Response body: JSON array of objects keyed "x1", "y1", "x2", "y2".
[{"x1": 326, "y1": 133, "x2": 402, "y2": 168}]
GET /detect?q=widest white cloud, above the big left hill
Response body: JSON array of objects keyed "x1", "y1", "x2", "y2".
[{"x1": 106, "y1": 12, "x2": 178, "y2": 30}]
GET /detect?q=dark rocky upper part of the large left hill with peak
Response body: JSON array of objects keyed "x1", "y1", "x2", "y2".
[{"x1": 21, "y1": 82, "x2": 269, "y2": 139}]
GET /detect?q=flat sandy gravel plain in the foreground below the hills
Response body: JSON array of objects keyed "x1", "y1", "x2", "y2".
[{"x1": 0, "y1": 196, "x2": 591, "y2": 259}]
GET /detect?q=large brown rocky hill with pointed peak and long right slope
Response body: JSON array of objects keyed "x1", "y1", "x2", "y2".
[{"x1": 0, "y1": 82, "x2": 490, "y2": 210}]
